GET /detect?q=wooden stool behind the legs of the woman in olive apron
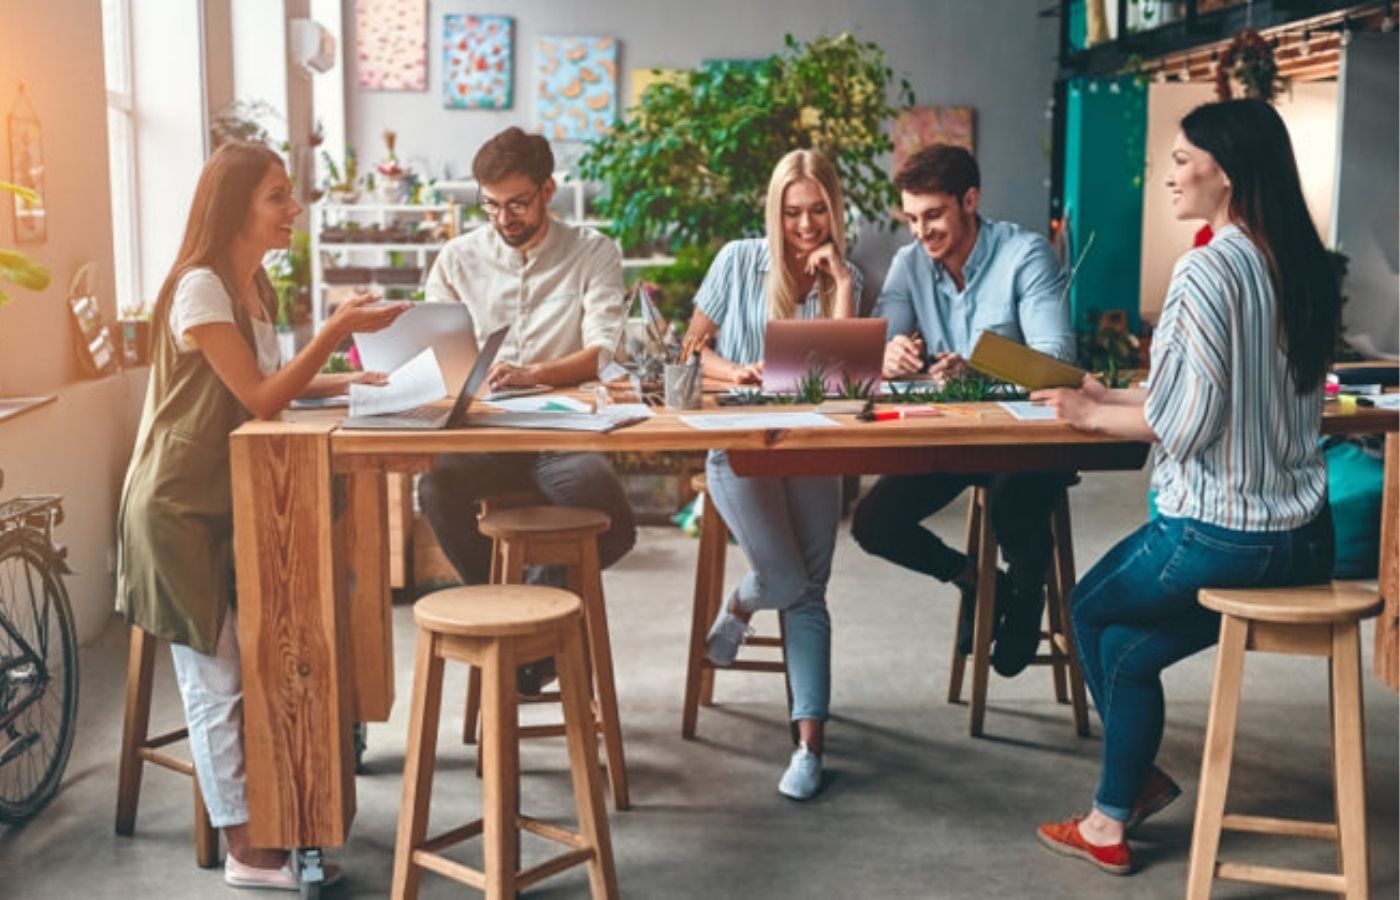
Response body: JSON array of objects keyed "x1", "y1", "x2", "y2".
[{"x1": 116, "y1": 626, "x2": 218, "y2": 869}]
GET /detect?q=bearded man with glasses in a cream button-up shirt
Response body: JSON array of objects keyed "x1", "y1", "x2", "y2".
[{"x1": 419, "y1": 127, "x2": 637, "y2": 693}]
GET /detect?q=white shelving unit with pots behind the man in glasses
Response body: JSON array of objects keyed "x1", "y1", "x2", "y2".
[{"x1": 311, "y1": 202, "x2": 456, "y2": 329}]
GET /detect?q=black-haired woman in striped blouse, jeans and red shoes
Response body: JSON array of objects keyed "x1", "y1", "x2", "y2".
[{"x1": 1033, "y1": 101, "x2": 1340, "y2": 875}]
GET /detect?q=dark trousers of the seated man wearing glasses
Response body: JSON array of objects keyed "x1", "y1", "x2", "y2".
[{"x1": 419, "y1": 453, "x2": 637, "y2": 584}]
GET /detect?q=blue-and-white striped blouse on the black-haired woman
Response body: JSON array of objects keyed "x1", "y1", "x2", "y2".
[{"x1": 1144, "y1": 225, "x2": 1327, "y2": 532}]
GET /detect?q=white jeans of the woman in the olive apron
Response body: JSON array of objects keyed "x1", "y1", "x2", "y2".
[{"x1": 171, "y1": 609, "x2": 248, "y2": 829}]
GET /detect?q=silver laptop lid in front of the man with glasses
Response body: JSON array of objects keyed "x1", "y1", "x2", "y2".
[{"x1": 354, "y1": 302, "x2": 477, "y2": 389}]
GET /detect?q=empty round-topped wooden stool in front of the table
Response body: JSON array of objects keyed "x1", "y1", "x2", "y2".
[{"x1": 392, "y1": 585, "x2": 617, "y2": 899}]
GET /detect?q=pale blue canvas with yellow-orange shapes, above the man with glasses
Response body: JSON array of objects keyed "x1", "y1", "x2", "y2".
[{"x1": 535, "y1": 36, "x2": 617, "y2": 141}]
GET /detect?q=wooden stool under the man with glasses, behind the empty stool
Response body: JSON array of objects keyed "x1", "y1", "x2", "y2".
[{"x1": 462, "y1": 507, "x2": 630, "y2": 809}]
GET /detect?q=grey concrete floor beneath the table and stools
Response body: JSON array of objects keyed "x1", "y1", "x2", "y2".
[{"x1": 0, "y1": 473, "x2": 1397, "y2": 899}]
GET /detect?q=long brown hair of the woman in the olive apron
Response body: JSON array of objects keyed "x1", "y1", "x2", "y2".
[{"x1": 151, "y1": 141, "x2": 283, "y2": 358}]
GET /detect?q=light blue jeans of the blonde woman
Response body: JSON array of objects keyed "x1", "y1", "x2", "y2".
[{"x1": 706, "y1": 451, "x2": 841, "y2": 721}]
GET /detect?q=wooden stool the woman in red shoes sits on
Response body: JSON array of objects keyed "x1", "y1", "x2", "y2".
[{"x1": 1186, "y1": 582, "x2": 1382, "y2": 899}]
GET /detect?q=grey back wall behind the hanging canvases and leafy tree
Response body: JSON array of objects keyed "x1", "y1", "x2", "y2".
[{"x1": 344, "y1": 0, "x2": 1058, "y2": 293}]
